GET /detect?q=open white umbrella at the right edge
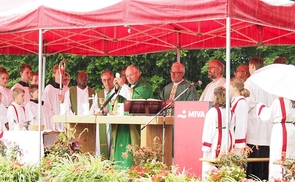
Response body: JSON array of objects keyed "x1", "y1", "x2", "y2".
[{"x1": 248, "y1": 64, "x2": 295, "y2": 100}]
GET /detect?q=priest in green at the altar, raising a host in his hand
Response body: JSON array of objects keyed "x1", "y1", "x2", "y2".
[{"x1": 111, "y1": 65, "x2": 153, "y2": 169}]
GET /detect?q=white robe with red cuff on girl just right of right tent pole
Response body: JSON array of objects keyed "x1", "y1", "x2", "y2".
[{"x1": 231, "y1": 96, "x2": 249, "y2": 148}]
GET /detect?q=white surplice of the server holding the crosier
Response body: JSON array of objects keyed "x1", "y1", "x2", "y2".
[{"x1": 42, "y1": 84, "x2": 65, "y2": 131}]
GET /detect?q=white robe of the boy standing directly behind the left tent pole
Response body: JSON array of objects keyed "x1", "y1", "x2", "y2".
[{"x1": 25, "y1": 101, "x2": 53, "y2": 130}]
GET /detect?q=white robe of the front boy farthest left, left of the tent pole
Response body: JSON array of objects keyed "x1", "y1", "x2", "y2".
[{"x1": 7, "y1": 102, "x2": 27, "y2": 130}]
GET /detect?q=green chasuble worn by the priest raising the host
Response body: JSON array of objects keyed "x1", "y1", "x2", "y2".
[{"x1": 110, "y1": 78, "x2": 153, "y2": 169}]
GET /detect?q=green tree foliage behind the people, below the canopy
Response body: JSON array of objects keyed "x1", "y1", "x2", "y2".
[{"x1": 0, "y1": 46, "x2": 295, "y2": 98}]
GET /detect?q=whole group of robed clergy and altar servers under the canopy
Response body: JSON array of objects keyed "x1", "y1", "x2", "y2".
[{"x1": 0, "y1": 56, "x2": 295, "y2": 179}]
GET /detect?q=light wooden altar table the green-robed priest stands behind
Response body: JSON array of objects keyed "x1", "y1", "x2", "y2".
[{"x1": 53, "y1": 115, "x2": 173, "y2": 166}]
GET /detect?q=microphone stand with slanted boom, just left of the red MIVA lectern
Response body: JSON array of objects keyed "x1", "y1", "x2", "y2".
[{"x1": 141, "y1": 83, "x2": 194, "y2": 163}]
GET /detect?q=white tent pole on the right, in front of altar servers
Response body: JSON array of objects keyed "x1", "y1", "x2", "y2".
[{"x1": 225, "y1": 17, "x2": 231, "y2": 154}]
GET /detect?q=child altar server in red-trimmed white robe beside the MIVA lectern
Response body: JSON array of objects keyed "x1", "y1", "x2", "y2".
[{"x1": 202, "y1": 86, "x2": 234, "y2": 180}]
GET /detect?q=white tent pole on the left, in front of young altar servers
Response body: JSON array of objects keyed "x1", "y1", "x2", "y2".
[{"x1": 37, "y1": 29, "x2": 44, "y2": 161}]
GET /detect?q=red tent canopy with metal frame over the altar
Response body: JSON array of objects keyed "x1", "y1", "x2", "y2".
[{"x1": 0, "y1": 0, "x2": 295, "y2": 56}]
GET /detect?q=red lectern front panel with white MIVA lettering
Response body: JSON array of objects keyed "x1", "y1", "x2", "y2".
[{"x1": 174, "y1": 101, "x2": 211, "y2": 177}]
